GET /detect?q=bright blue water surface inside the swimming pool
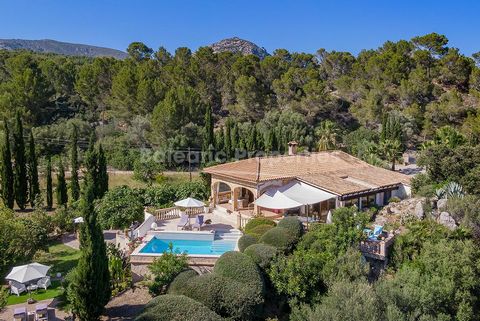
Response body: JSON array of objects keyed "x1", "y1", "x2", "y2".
[{"x1": 140, "y1": 237, "x2": 236, "y2": 255}]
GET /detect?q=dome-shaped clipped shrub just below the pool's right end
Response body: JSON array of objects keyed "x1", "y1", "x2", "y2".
[{"x1": 213, "y1": 252, "x2": 264, "y2": 294}]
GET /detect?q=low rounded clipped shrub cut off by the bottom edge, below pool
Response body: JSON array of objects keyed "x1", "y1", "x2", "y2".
[{"x1": 135, "y1": 294, "x2": 222, "y2": 321}]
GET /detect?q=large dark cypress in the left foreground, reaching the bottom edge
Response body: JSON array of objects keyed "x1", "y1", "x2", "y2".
[{"x1": 67, "y1": 176, "x2": 111, "y2": 321}]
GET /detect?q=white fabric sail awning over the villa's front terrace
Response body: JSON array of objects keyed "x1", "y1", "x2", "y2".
[{"x1": 255, "y1": 181, "x2": 336, "y2": 209}]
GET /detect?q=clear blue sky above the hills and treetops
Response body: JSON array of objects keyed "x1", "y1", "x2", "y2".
[{"x1": 0, "y1": 0, "x2": 480, "y2": 55}]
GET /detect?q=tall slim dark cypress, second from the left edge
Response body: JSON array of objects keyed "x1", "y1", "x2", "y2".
[{"x1": 13, "y1": 112, "x2": 28, "y2": 210}]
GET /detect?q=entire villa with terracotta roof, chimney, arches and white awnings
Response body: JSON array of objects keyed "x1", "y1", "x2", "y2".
[{"x1": 204, "y1": 142, "x2": 410, "y2": 225}]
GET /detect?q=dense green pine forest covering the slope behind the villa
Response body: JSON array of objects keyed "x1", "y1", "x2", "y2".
[{"x1": 0, "y1": 33, "x2": 480, "y2": 169}]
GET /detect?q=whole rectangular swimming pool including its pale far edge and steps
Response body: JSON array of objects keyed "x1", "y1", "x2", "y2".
[{"x1": 138, "y1": 232, "x2": 238, "y2": 256}]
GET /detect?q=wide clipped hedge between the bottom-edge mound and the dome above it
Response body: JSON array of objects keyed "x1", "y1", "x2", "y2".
[{"x1": 168, "y1": 273, "x2": 263, "y2": 320}]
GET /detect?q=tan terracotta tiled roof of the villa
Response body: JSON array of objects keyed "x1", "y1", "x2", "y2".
[{"x1": 204, "y1": 151, "x2": 410, "y2": 195}]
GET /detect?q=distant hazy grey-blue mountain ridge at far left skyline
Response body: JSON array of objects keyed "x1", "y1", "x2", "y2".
[{"x1": 0, "y1": 39, "x2": 127, "y2": 59}]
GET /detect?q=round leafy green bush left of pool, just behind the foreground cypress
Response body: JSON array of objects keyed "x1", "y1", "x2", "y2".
[{"x1": 97, "y1": 186, "x2": 143, "y2": 229}]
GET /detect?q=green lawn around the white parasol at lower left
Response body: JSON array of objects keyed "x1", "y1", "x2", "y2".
[{"x1": 7, "y1": 241, "x2": 80, "y2": 305}]
